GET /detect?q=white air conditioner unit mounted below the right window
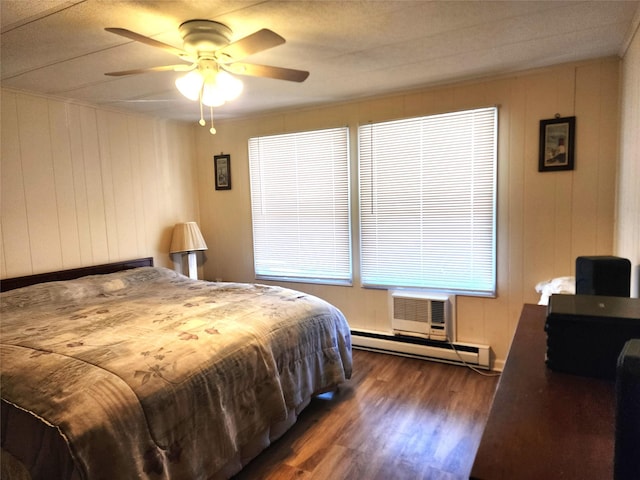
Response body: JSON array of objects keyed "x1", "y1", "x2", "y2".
[{"x1": 389, "y1": 290, "x2": 455, "y2": 342}]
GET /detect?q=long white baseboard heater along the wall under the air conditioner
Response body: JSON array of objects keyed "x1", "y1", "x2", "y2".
[{"x1": 351, "y1": 330, "x2": 491, "y2": 370}]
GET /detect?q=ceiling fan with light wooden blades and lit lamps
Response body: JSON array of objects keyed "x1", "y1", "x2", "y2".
[{"x1": 105, "y1": 19, "x2": 309, "y2": 133}]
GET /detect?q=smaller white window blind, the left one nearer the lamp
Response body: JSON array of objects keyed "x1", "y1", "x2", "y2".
[{"x1": 249, "y1": 127, "x2": 351, "y2": 283}]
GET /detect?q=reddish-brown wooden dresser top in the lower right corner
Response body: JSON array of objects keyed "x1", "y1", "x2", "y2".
[{"x1": 471, "y1": 305, "x2": 615, "y2": 480}]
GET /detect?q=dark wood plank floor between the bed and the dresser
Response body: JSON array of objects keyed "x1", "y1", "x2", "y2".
[{"x1": 235, "y1": 350, "x2": 497, "y2": 480}]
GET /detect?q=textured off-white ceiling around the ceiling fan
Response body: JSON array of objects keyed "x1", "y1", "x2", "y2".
[{"x1": 0, "y1": 0, "x2": 640, "y2": 121}]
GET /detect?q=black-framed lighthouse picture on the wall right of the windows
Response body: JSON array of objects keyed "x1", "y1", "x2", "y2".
[{"x1": 538, "y1": 117, "x2": 576, "y2": 172}]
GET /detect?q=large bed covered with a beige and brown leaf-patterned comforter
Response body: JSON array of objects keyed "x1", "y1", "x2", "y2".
[{"x1": 0, "y1": 259, "x2": 352, "y2": 480}]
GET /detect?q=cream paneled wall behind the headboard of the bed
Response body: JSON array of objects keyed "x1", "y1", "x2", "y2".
[{"x1": 0, "y1": 89, "x2": 198, "y2": 278}]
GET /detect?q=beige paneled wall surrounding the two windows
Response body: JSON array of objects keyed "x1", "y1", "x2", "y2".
[{"x1": 196, "y1": 58, "x2": 624, "y2": 367}]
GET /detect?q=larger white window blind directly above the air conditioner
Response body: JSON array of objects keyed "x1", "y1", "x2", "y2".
[{"x1": 358, "y1": 107, "x2": 497, "y2": 295}]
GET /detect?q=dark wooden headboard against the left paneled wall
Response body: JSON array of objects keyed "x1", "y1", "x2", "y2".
[{"x1": 0, "y1": 257, "x2": 153, "y2": 292}]
